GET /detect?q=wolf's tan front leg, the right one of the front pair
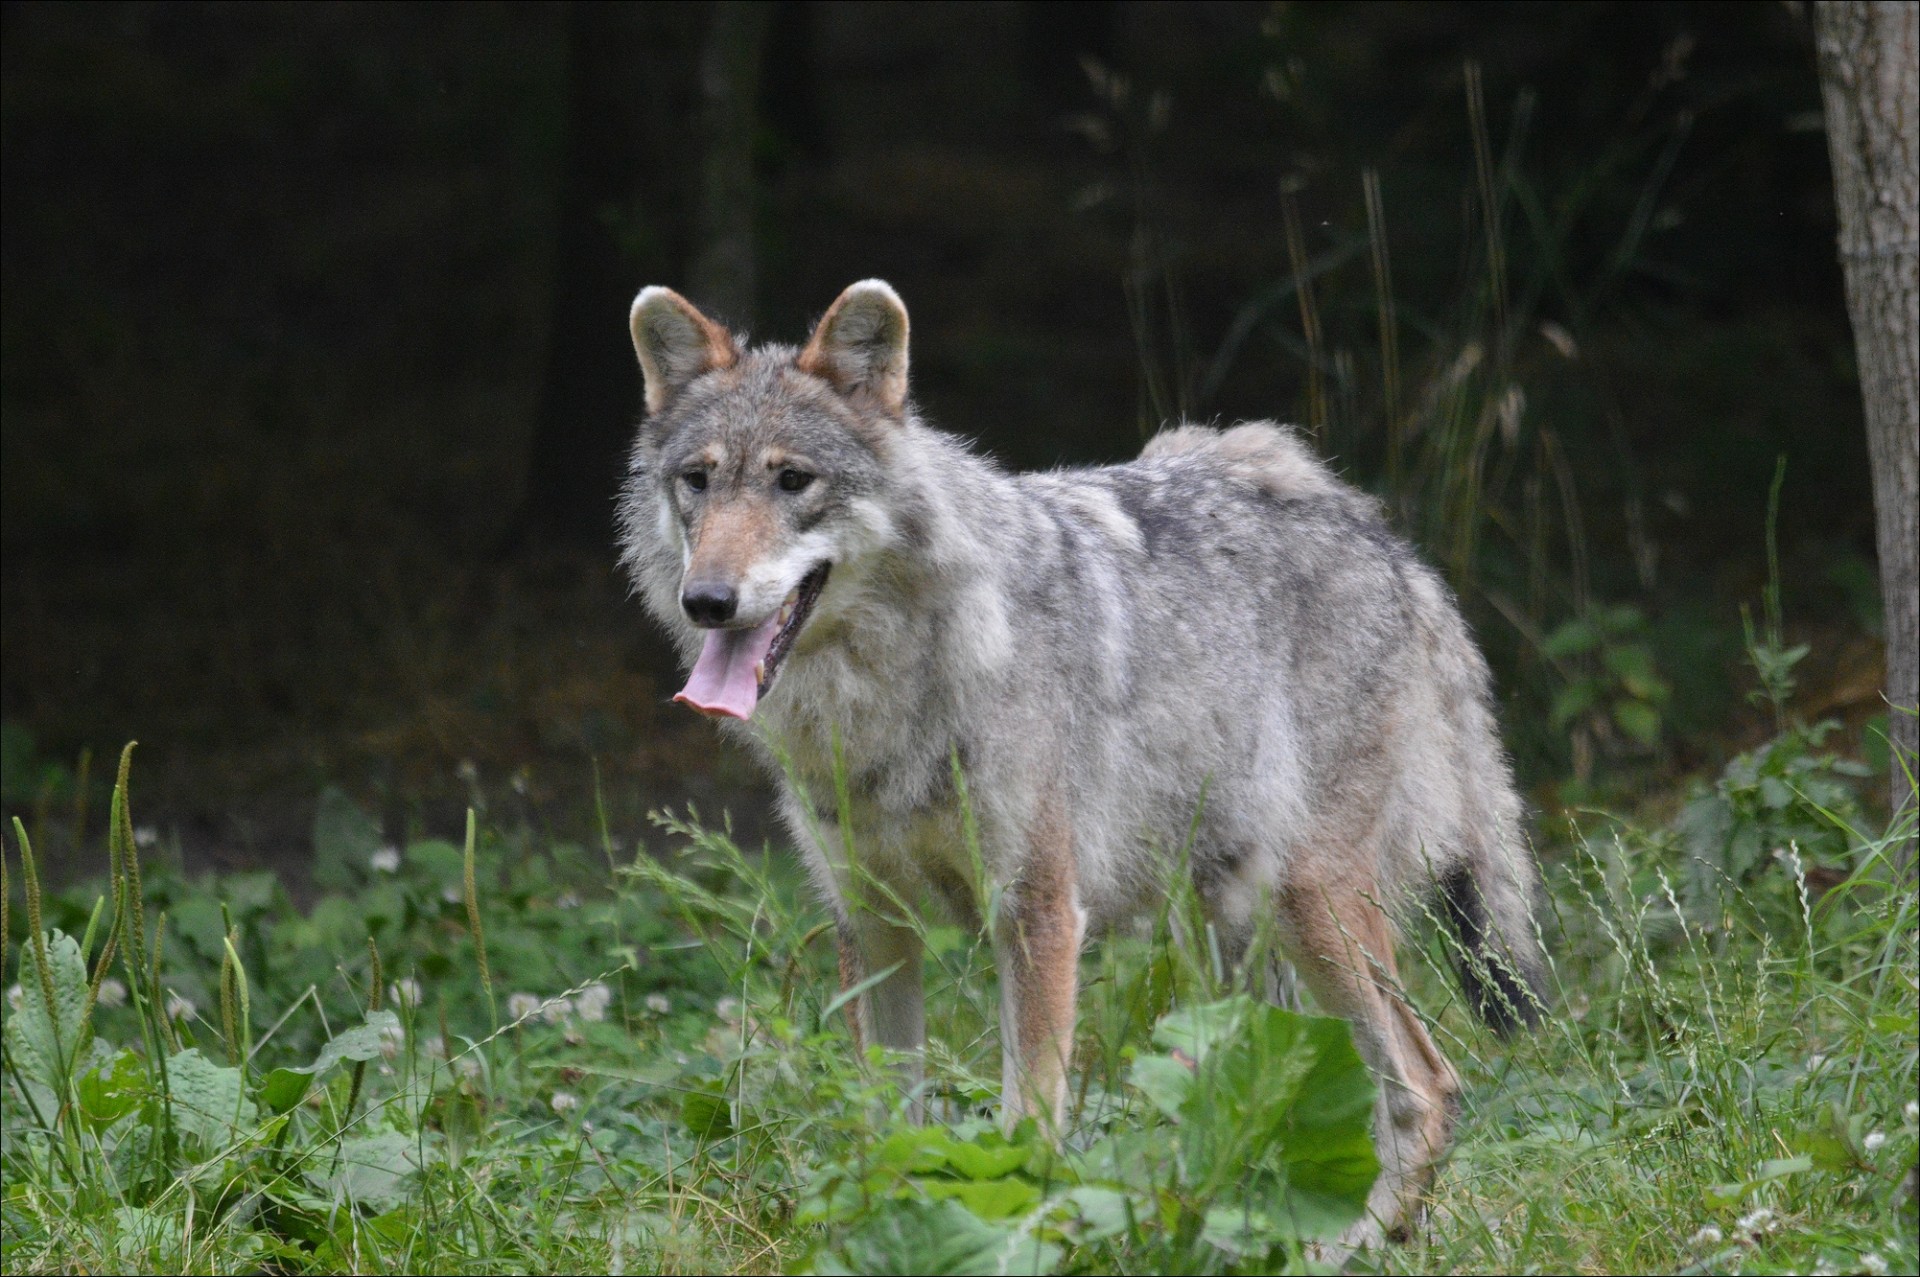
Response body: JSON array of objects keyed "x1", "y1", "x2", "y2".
[{"x1": 993, "y1": 822, "x2": 1087, "y2": 1137}]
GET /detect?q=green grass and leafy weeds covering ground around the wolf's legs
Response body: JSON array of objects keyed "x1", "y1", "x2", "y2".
[{"x1": 0, "y1": 710, "x2": 1920, "y2": 1273}]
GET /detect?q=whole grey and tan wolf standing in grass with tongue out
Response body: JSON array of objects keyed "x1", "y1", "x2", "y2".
[{"x1": 618, "y1": 280, "x2": 1544, "y2": 1235}]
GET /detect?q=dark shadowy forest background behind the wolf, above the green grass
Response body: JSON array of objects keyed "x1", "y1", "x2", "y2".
[{"x1": 0, "y1": 2, "x2": 1882, "y2": 868}]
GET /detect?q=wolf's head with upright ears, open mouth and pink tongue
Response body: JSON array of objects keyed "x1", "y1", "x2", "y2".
[{"x1": 620, "y1": 280, "x2": 910, "y2": 718}]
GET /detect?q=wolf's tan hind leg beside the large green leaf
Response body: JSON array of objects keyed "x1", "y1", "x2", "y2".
[{"x1": 1281, "y1": 874, "x2": 1459, "y2": 1242}]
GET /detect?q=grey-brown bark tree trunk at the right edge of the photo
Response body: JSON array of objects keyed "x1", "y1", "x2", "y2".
[{"x1": 1814, "y1": 0, "x2": 1920, "y2": 856}]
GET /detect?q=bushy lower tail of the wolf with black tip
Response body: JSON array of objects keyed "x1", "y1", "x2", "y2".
[{"x1": 1438, "y1": 839, "x2": 1548, "y2": 1035}]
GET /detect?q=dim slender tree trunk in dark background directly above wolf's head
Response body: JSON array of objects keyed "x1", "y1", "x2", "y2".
[{"x1": 687, "y1": 0, "x2": 774, "y2": 328}]
